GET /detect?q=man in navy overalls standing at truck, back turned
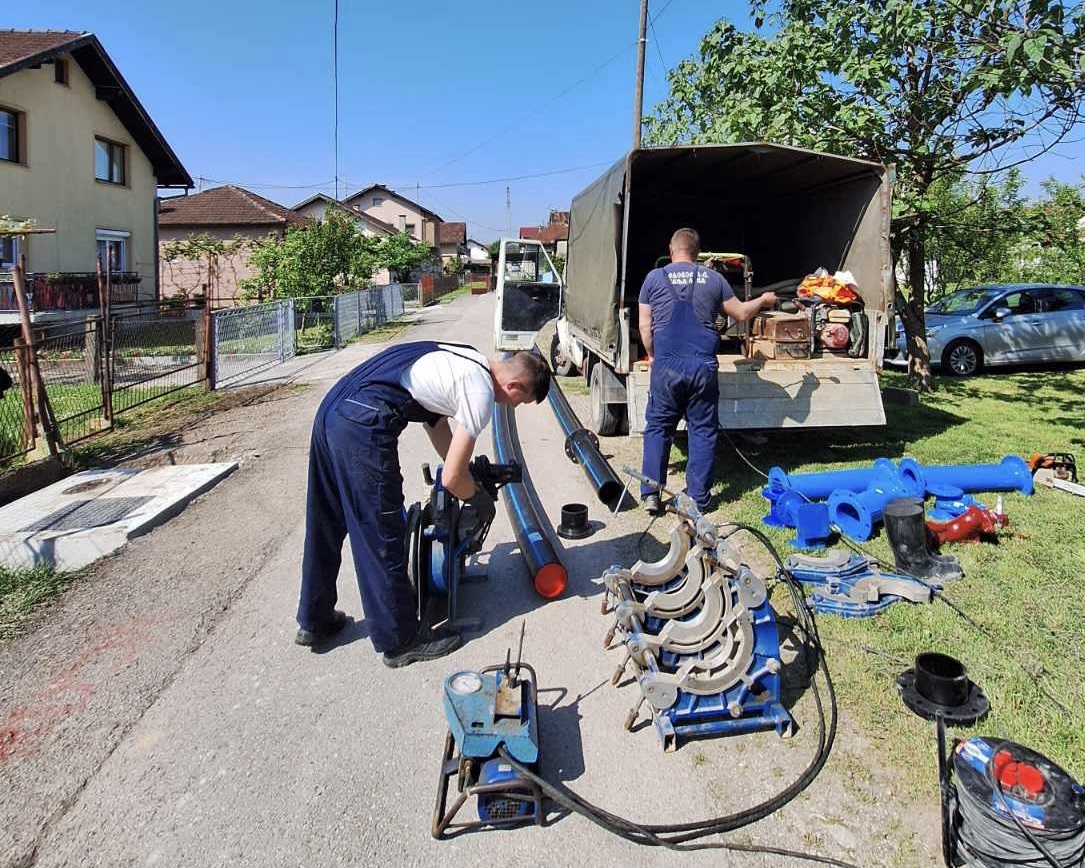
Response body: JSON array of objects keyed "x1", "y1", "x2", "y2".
[{"x1": 638, "y1": 229, "x2": 776, "y2": 514}]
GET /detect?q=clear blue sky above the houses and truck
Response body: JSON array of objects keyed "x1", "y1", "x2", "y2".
[{"x1": 10, "y1": 0, "x2": 1082, "y2": 241}]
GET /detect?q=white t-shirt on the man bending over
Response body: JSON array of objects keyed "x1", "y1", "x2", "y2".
[{"x1": 399, "y1": 344, "x2": 494, "y2": 439}]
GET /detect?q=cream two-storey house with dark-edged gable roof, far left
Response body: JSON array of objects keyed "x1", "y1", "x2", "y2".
[{"x1": 0, "y1": 30, "x2": 192, "y2": 323}]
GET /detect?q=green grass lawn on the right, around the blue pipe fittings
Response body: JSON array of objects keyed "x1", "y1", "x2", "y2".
[{"x1": 672, "y1": 368, "x2": 1085, "y2": 792}]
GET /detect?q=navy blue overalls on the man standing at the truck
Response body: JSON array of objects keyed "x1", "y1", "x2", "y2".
[{"x1": 640, "y1": 266, "x2": 719, "y2": 509}]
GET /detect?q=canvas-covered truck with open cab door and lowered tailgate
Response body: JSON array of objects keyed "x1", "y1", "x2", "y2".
[{"x1": 495, "y1": 142, "x2": 893, "y2": 434}]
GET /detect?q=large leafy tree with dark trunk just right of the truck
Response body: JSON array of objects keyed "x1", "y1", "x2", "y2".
[{"x1": 648, "y1": 0, "x2": 1085, "y2": 390}]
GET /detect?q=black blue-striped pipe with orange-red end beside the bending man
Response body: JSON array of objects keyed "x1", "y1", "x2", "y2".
[{"x1": 494, "y1": 405, "x2": 569, "y2": 600}]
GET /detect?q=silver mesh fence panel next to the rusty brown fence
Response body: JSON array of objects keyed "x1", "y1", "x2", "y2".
[{"x1": 212, "y1": 299, "x2": 296, "y2": 386}]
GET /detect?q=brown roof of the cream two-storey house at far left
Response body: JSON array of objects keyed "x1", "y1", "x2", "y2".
[{"x1": 0, "y1": 30, "x2": 192, "y2": 187}]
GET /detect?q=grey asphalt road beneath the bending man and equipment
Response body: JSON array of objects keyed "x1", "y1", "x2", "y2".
[{"x1": 0, "y1": 296, "x2": 937, "y2": 866}]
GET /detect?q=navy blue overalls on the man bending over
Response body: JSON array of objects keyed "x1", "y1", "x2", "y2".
[{"x1": 297, "y1": 341, "x2": 488, "y2": 651}]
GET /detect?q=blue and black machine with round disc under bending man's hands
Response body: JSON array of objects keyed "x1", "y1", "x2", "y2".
[{"x1": 407, "y1": 456, "x2": 523, "y2": 629}]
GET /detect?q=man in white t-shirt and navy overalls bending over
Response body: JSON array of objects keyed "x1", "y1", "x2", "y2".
[{"x1": 295, "y1": 341, "x2": 550, "y2": 667}]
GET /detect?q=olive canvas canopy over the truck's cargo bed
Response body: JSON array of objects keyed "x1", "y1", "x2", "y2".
[{"x1": 565, "y1": 142, "x2": 892, "y2": 349}]
